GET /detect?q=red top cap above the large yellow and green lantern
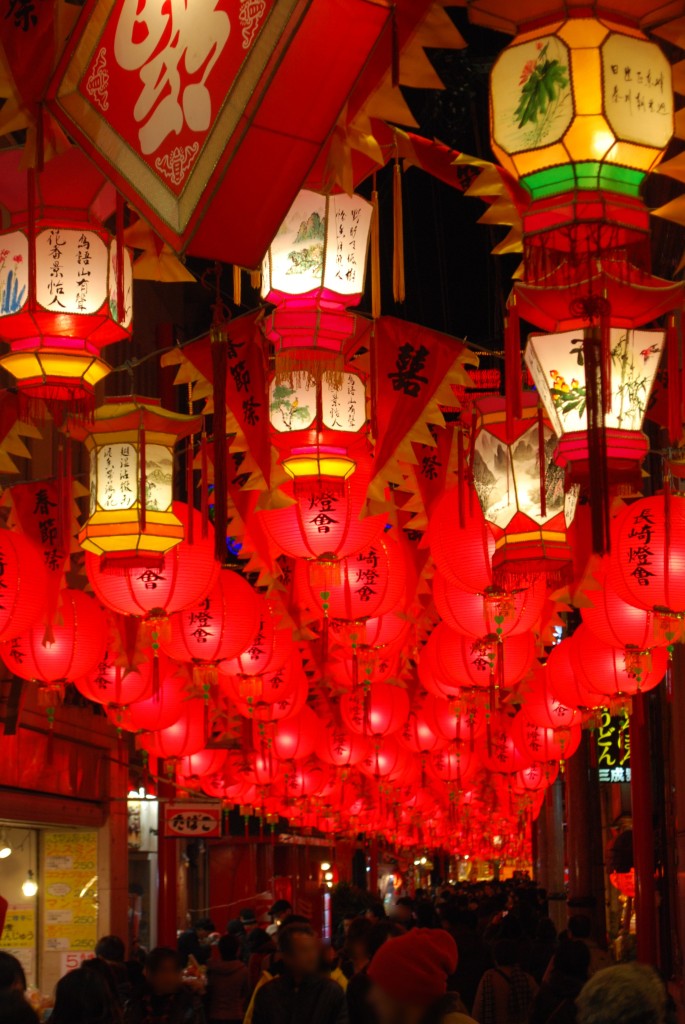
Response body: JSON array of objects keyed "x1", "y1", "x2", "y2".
[{"x1": 467, "y1": 0, "x2": 685, "y2": 36}]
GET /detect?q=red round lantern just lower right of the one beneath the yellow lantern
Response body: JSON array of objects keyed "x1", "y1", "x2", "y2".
[{"x1": 160, "y1": 569, "x2": 261, "y2": 663}]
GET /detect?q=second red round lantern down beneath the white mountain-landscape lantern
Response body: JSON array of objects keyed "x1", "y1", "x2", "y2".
[{"x1": 419, "y1": 623, "x2": 536, "y2": 696}]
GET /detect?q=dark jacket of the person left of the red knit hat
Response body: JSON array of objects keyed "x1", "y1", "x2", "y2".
[{"x1": 252, "y1": 974, "x2": 348, "y2": 1024}]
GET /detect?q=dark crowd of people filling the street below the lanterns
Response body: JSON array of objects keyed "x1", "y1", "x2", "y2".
[{"x1": 0, "y1": 885, "x2": 667, "y2": 1024}]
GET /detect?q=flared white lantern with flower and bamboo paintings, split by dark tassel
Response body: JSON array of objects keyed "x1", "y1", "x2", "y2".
[{"x1": 525, "y1": 328, "x2": 665, "y2": 481}]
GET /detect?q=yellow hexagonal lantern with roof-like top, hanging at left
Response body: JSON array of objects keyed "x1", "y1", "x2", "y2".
[{"x1": 70, "y1": 397, "x2": 202, "y2": 569}]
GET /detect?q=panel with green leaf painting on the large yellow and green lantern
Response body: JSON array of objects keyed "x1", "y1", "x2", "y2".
[{"x1": 490, "y1": 36, "x2": 573, "y2": 153}]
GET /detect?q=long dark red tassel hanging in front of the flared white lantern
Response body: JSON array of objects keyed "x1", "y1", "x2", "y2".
[{"x1": 583, "y1": 328, "x2": 610, "y2": 555}]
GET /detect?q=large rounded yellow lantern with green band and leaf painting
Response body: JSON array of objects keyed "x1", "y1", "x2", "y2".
[{"x1": 490, "y1": 16, "x2": 674, "y2": 200}]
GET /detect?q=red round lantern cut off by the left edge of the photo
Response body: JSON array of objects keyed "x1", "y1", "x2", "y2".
[{"x1": 0, "y1": 529, "x2": 47, "y2": 641}]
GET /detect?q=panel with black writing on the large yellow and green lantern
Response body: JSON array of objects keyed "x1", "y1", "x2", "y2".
[{"x1": 602, "y1": 33, "x2": 674, "y2": 150}]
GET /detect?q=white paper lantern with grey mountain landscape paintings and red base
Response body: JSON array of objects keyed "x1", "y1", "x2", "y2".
[{"x1": 473, "y1": 393, "x2": 577, "y2": 582}]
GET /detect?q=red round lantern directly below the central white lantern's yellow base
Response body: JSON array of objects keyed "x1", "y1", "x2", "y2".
[{"x1": 258, "y1": 466, "x2": 385, "y2": 560}]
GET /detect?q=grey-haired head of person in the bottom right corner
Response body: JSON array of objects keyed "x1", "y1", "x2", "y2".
[{"x1": 575, "y1": 964, "x2": 666, "y2": 1024}]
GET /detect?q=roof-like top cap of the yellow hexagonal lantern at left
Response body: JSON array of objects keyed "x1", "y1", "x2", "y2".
[{"x1": 69, "y1": 395, "x2": 202, "y2": 440}]
